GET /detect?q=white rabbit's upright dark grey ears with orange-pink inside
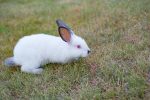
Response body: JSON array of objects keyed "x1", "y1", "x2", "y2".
[{"x1": 56, "y1": 20, "x2": 73, "y2": 42}]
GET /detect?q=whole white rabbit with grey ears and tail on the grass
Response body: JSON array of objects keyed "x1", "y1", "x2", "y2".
[{"x1": 5, "y1": 20, "x2": 90, "y2": 74}]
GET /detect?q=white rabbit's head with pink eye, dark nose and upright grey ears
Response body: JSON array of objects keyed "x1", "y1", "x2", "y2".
[{"x1": 56, "y1": 20, "x2": 90, "y2": 57}]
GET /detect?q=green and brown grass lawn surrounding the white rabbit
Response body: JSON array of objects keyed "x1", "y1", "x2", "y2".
[{"x1": 0, "y1": 0, "x2": 150, "y2": 100}]
